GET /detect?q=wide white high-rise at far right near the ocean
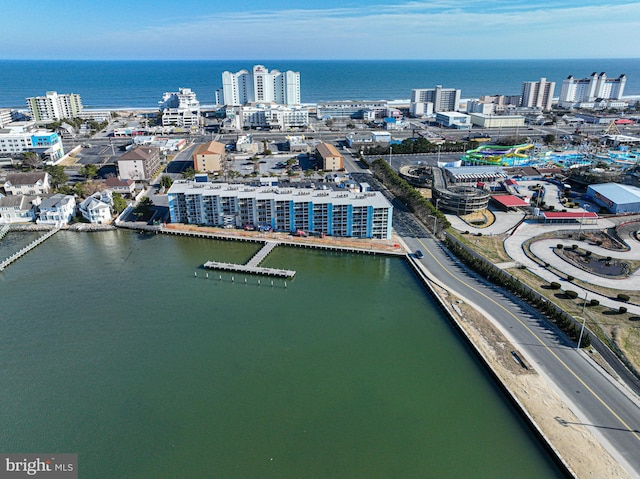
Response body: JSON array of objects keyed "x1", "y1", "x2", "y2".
[{"x1": 558, "y1": 72, "x2": 627, "y2": 108}]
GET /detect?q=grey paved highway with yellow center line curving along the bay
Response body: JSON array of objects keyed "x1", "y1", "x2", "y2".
[{"x1": 352, "y1": 170, "x2": 640, "y2": 477}]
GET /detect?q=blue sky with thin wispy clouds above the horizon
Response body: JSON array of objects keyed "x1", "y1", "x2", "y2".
[{"x1": 0, "y1": 0, "x2": 640, "y2": 60}]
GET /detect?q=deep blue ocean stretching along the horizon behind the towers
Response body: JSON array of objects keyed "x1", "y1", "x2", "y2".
[{"x1": 0, "y1": 59, "x2": 640, "y2": 109}]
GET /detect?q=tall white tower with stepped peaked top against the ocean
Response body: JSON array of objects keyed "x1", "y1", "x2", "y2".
[{"x1": 216, "y1": 65, "x2": 300, "y2": 105}]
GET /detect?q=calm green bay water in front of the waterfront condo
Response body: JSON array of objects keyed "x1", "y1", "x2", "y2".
[{"x1": 0, "y1": 231, "x2": 561, "y2": 478}]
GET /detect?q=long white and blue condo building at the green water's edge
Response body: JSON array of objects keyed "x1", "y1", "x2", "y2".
[{"x1": 168, "y1": 180, "x2": 393, "y2": 239}]
